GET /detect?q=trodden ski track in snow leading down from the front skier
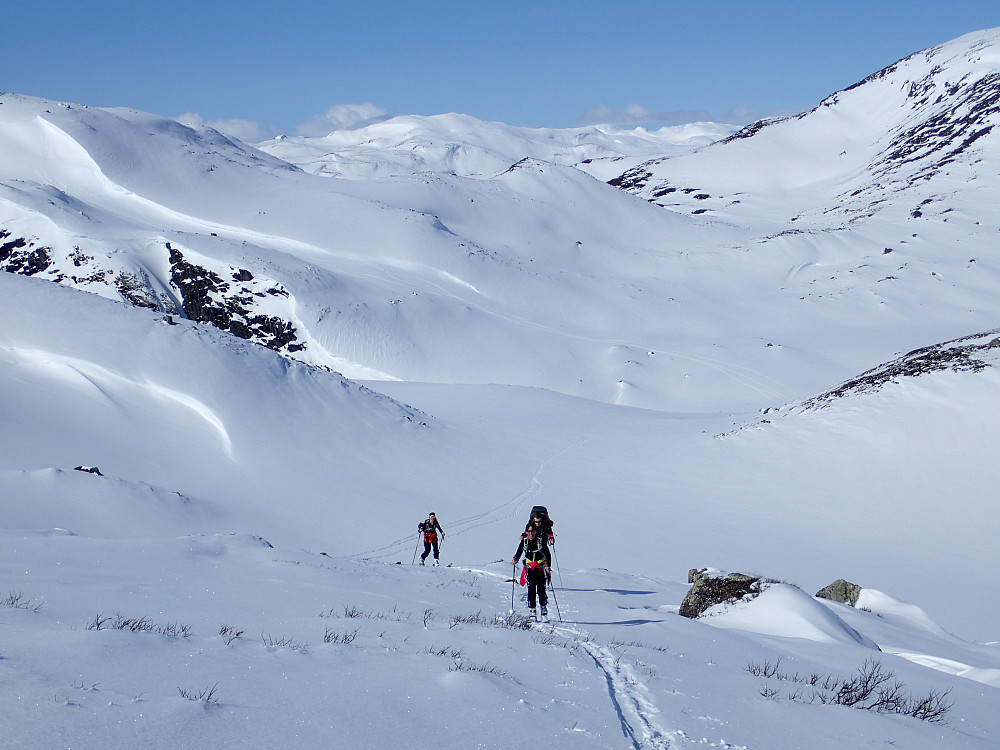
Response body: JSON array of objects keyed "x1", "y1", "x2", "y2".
[{"x1": 551, "y1": 627, "x2": 684, "y2": 750}]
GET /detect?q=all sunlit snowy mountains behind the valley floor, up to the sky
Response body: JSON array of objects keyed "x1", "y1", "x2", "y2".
[{"x1": 0, "y1": 30, "x2": 1000, "y2": 411}]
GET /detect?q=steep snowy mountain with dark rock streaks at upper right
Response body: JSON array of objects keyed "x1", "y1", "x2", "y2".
[{"x1": 600, "y1": 29, "x2": 1000, "y2": 225}]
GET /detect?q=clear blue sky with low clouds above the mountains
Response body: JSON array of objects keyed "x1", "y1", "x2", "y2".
[{"x1": 9, "y1": 0, "x2": 1000, "y2": 134}]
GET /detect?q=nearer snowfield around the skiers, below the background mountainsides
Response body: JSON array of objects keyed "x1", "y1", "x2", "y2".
[{"x1": 0, "y1": 260, "x2": 1000, "y2": 748}]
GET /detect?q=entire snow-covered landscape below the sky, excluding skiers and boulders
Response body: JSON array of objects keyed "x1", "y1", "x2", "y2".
[{"x1": 0, "y1": 23, "x2": 1000, "y2": 750}]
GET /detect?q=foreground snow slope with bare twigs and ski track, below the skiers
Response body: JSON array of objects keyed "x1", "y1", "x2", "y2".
[{"x1": 7, "y1": 532, "x2": 997, "y2": 750}]
